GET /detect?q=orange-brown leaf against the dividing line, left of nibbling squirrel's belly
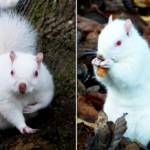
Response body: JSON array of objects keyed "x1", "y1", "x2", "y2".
[{"x1": 77, "y1": 95, "x2": 98, "y2": 123}]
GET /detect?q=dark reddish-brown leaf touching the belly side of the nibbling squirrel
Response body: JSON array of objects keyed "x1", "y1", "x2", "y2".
[{"x1": 85, "y1": 92, "x2": 106, "y2": 111}]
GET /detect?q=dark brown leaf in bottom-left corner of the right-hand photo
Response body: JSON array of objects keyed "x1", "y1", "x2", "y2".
[{"x1": 77, "y1": 131, "x2": 89, "y2": 150}]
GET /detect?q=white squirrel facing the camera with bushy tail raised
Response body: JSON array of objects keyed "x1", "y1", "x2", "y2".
[{"x1": 0, "y1": 0, "x2": 54, "y2": 134}]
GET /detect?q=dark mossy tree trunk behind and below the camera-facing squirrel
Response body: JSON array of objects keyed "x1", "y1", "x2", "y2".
[{"x1": 0, "y1": 0, "x2": 76, "y2": 150}]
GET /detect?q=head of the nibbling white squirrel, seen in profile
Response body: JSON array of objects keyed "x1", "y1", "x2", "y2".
[{"x1": 97, "y1": 16, "x2": 139, "y2": 61}]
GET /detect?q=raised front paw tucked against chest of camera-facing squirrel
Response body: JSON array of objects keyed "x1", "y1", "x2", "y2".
[{"x1": 23, "y1": 103, "x2": 39, "y2": 114}]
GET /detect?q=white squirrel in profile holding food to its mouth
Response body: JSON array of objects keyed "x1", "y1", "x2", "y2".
[{"x1": 92, "y1": 16, "x2": 150, "y2": 146}]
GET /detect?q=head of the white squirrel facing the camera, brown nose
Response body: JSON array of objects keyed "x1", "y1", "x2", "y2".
[{"x1": 10, "y1": 51, "x2": 43, "y2": 94}]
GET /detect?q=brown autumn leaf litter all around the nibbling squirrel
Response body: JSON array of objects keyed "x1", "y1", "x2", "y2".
[{"x1": 77, "y1": 0, "x2": 150, "y2": 150}]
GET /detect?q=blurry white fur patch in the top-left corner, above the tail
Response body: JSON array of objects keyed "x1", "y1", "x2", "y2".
[{"x1": 0, "y1": 0, "x2": 19, "y2": 9}]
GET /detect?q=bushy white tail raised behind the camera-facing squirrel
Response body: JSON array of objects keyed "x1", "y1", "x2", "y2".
[{"x1": 0, "y1": 11, "x2": 38, "y2": 54}]
